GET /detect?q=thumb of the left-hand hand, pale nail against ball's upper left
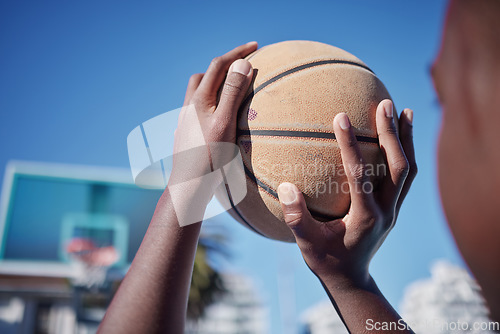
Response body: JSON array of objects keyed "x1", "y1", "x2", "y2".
[{"x1": 217, "y1": 59, "x2": 253, "y2": 117}]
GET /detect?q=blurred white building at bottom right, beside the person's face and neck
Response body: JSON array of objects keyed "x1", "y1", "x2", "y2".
[{"x1": 400, "y1": 261, "x2": 498, "y2": 334}]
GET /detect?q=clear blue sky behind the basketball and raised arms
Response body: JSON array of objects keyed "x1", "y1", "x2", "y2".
[{"x1": 0, "y1": 0, "x2": 461, "y2": 333}]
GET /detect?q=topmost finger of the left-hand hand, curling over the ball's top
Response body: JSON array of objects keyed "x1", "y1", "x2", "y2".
[{"x1": 195, "y1": 42, "x2": 257, "y2": 105}]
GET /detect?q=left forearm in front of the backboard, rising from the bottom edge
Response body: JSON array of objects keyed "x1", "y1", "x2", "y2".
[{"x1": 99, "y1": 188, "x2": 201, "y2": 333}]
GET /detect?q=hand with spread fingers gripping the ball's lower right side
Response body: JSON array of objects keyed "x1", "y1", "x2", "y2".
[{"x1": 278, "y1": 100, "x2": 417, "y2": 285}]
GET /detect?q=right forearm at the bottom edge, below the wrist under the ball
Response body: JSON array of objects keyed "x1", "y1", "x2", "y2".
[{"x1": 320, "y1": 277, "x2": 413, "y2": 334}]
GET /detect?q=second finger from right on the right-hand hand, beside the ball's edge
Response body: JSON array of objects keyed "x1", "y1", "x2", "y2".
[{"x1": 376, "y1": 100, "x2": 409, "y2": 210}]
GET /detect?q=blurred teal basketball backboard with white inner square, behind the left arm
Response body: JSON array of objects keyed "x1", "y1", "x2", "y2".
[{"x1": 0, "y1": 162, "x2": 162, "y2": 277}]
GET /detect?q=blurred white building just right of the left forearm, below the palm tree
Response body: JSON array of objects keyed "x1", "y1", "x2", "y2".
[{"x1": 186, "y1": 274, "x2": 270, "y2": 334}]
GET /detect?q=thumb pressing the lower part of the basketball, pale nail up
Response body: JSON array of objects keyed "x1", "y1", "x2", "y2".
[{"x1": 278, "y1": 182, "x2": 315, "y2": 242}]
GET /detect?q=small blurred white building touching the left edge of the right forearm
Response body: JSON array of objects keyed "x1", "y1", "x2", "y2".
[{"x1": 301, "y1": 300, "x2": 349, "y2": 334}]
